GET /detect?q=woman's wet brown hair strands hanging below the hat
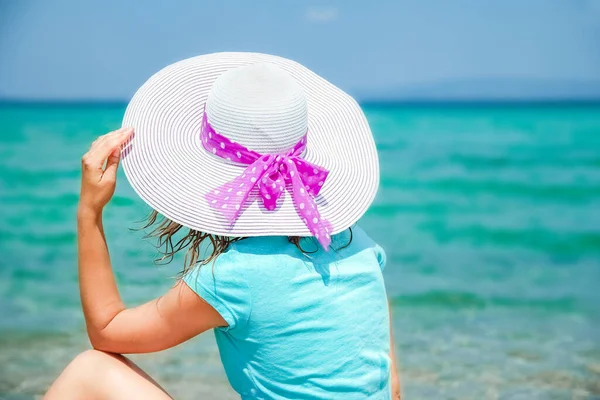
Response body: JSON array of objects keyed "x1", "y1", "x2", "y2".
[{"x1": 139, "y1": 210, "x2": 352, "y2": 276}]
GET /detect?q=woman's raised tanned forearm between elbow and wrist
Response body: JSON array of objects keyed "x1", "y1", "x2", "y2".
[{"x1": 77, "y1": 207, "x2": 124, "y2": 345}]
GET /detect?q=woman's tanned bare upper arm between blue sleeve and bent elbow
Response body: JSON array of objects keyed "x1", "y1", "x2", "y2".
[{"x1": 90, "y1": 281, "x2": 227, "y2": 353}]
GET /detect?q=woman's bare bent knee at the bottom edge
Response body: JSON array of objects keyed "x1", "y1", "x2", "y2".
[{"x1": 44, "y1": 350, "x2": 171, "y2": 400}]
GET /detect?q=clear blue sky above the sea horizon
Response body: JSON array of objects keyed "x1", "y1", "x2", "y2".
[{"x1": 0, "y1": 0, "x2": 600, "y2": 99}]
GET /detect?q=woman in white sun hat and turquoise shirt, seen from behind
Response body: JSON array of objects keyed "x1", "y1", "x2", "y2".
[{"x1": 45, "y1": 53, "x2": 400, "y2": 400}]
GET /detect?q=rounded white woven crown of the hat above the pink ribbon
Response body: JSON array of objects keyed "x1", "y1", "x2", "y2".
[{"x1": 206, "y1": 63, "x2": 308, "y2": 154}]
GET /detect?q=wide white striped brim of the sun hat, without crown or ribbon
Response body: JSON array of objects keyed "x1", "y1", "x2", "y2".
[{"x1": 122, "y1": 53, "x2": 379, "y2": 237}]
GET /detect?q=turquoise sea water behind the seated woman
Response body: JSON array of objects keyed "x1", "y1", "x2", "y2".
[{"x1": 0, "y1": 105, "x2": 600, "y2": 399}]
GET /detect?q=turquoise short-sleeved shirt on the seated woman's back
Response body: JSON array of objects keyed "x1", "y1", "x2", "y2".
[{"x1": 184, "y1": 226, "x2": 391, "y2": 399}]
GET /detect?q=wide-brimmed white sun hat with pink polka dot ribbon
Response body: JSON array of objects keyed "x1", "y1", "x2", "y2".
[{"x1": 122, "y1": 52, "x2": 379, "y2": 248}]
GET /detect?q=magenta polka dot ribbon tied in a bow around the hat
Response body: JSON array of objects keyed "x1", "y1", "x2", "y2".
[{"x1": 200, "y1": 113, "x2": 331, "y2": 250}]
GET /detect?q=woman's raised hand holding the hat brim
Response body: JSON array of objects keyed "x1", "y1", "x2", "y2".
[{"x1": 79, "y1": 128, "x2": 133, "y2": 216}]
